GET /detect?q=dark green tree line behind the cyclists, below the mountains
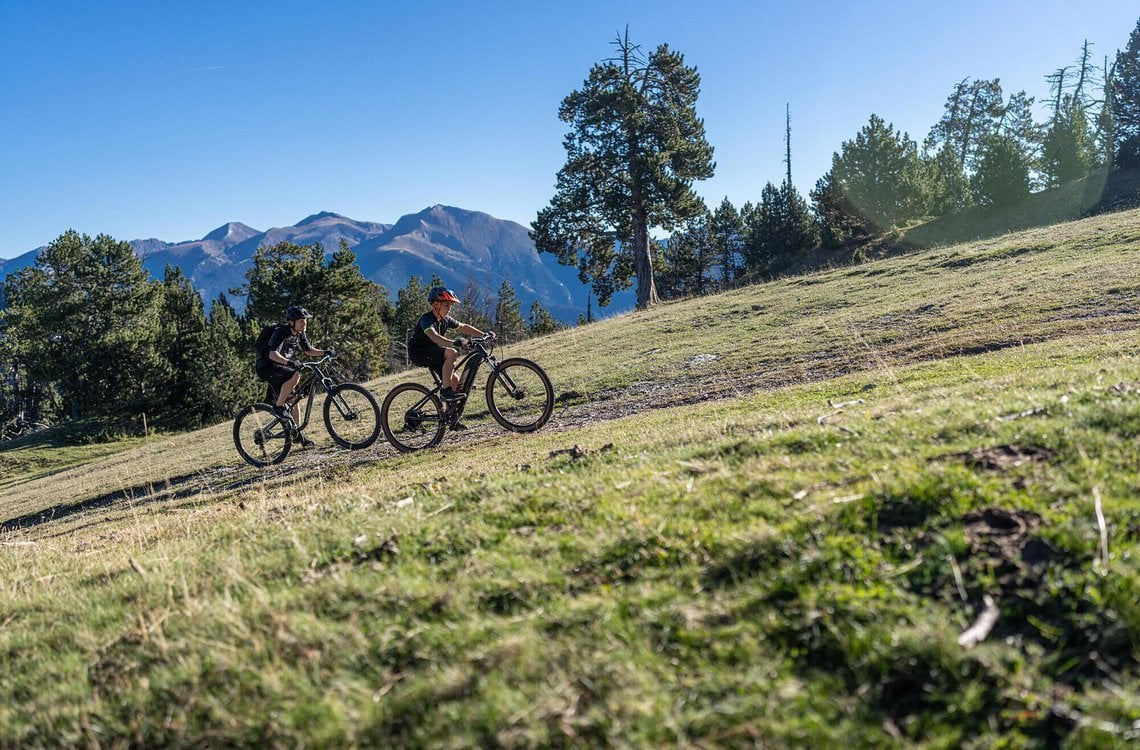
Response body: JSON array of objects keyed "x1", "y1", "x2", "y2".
[{"x1": 0, "y1": 237, "x2": 562, "y2": 441}]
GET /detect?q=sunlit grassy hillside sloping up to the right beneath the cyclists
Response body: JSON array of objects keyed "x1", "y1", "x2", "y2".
[{"x1": 0, "y1": 211, "x2": 1140, "y2": 748}]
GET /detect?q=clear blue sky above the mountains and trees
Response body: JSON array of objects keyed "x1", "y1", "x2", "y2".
[{"x1": 0, "y1": 0, "x2": 1140, "y2": 258}]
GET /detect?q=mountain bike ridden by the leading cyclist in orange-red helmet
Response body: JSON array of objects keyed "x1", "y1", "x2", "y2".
[{"x1": 380, "y1": 334, "x2": 554, "y2": 453}]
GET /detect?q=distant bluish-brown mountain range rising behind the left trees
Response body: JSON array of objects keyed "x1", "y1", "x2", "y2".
[{"x1": 0, "y1": 205, "x2": 635, "y2": 323}]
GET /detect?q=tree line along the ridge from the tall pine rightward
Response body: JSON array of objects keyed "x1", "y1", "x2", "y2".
[{"x1": 531, "y1": 21, "x2": 1140, "y2": 308}]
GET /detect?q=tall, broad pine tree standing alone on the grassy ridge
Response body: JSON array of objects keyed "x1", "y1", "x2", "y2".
[{"x1": 531, "y1": 30, "x2": 715, "y2": 308}]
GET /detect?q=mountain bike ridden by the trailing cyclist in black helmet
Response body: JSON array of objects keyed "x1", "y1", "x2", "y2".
[{"x1": 234, "y1": 354, "x2": 380, "y2": 466}]
